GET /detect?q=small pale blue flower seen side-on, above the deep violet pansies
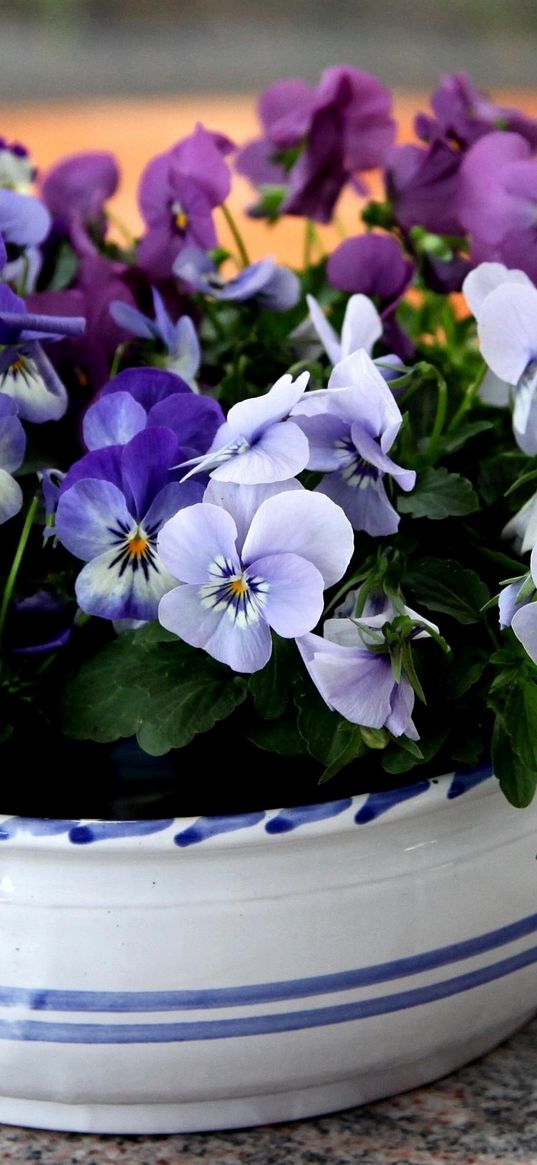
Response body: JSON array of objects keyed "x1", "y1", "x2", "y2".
[{"x1": 109, "y1": 288, "x2": 202, "y2": 389}]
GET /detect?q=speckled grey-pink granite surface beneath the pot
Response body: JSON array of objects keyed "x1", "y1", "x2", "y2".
[{"x1": 0, "y1": 1019, "x2": 537, "y2": 1165}]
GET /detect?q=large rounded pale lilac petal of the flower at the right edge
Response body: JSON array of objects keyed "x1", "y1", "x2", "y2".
[{"x1": 478, "y1": 283, "x2": 537, "y2": 384}]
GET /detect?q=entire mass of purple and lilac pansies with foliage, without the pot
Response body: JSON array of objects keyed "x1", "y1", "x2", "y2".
[{"x1": 0, "y1": 66, "x2": 537, "y2": 811}]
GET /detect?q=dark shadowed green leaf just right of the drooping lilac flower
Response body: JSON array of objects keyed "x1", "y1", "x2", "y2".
[{"x1": 405, "y1": 558, "x2": 489, "y2": 623}]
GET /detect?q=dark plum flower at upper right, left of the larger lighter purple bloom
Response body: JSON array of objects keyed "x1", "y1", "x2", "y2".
[{"x1": 386, "y1": 139, "x2": 462, "y2": 235}]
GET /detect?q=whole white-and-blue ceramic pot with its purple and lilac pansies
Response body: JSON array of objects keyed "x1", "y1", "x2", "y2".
[{"x1": 0, "y1": 68, "x2": 537, "y2": 1132}]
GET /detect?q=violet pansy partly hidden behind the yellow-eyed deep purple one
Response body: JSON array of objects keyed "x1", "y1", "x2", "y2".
[{"x1": 83, "y1": 368, "x2": 224, "y2": 460}]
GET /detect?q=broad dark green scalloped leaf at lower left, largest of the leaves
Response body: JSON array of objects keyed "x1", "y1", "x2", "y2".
[{"x1": 62, "y1": 623, "x2": 247, "y2": 756}]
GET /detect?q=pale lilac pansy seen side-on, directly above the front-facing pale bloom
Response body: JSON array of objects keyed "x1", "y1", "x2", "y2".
[{"x1": 178, "y1": 372, "x2": 310, "y2": 486}]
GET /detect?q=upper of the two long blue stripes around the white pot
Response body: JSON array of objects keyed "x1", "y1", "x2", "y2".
[{"x1": 0, "y1": 913, "x2": 537, "y2": 1012}]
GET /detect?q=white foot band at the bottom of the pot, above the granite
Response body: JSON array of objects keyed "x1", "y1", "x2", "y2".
[{"x1": 0, "y1": 1012, "x2": 526, "y2": 1136}]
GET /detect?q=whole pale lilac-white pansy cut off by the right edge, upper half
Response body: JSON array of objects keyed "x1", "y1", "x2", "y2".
[{"x1": 464, "y1": 263, "x2": 537, "y2": 457}]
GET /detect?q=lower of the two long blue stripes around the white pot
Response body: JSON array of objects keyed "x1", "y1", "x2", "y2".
[{"x1": 0, "y1": 947, "x2": 537, "y2": 1044}]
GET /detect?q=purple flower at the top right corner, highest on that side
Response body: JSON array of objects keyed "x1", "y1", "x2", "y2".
[{"x1": 416, "y1": 73, "x2": 537, "y2": 149}]
